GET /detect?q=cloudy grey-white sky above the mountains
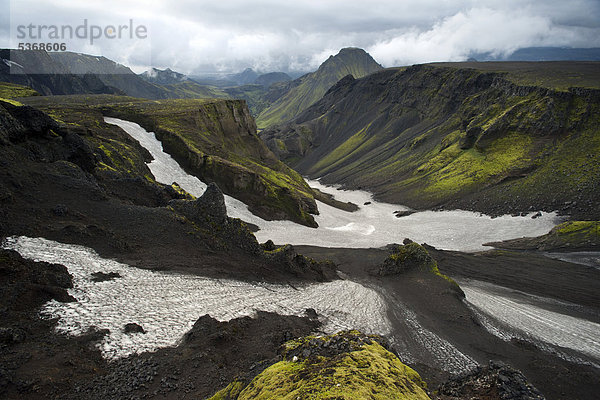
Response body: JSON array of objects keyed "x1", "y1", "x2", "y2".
[{"x1": 0, "y1": 0, "x2": 600, "y2": 74}]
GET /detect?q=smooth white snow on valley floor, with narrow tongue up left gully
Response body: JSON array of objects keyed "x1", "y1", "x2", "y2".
[{"x1": 105, "y1": 118, "x2": 560, "y2": 251}]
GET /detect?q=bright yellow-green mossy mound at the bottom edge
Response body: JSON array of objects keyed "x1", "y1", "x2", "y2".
[{"x1": 212, "y1": 331, "x2": 429, "y2": 400}]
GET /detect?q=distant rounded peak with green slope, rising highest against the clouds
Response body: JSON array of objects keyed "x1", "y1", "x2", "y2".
[{"x1": 257, "y1": 49, "x2": 381, "y2": 128}]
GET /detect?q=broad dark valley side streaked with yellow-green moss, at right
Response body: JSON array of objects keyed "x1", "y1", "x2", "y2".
[{"x1": 261, "y1": 64, "x2": 600, "y2": 217}]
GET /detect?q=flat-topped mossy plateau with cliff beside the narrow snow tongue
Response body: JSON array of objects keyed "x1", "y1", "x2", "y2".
[{"x1": 18, "y1": 95, "x2": 316, "y2": 226}]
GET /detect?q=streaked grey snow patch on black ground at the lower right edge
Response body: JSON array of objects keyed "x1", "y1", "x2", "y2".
[{"x1": 460, "y1": 281, "x2": 600, "y2": 361}]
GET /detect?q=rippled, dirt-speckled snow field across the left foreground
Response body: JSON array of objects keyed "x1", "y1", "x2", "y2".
[{"x1": 3, "y1": 237, "x2": 390, "y2": 358}]
